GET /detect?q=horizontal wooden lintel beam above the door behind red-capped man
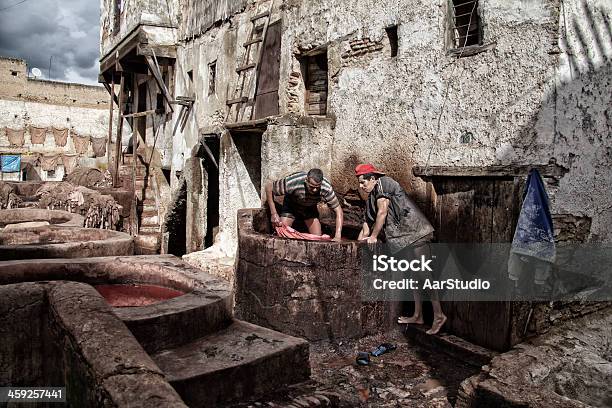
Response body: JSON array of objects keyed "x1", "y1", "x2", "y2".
[{"x1": 412, "y1": 164, "x2": 568, "y2": 178}]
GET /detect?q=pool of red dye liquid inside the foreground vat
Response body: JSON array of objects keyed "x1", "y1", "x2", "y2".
[{"x1": 94, "y1": 284, "x2": 184, "y2": 307}]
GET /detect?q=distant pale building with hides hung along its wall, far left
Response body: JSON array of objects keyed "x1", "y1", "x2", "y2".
[{"x1": 0, "y1": 57, "x2": 109, "y2": 181}]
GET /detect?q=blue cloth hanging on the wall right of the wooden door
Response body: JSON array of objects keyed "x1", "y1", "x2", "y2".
[{"x1": 508, "y1": 169, "x2": 556, "y2": 284}]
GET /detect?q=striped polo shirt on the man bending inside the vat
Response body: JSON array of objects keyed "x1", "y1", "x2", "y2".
[{"x1": 272, "y1": 171, "x2": 340, "y2": 209}]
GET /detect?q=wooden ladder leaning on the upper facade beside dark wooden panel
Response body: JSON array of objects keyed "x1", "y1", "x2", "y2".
[{"x1": 225, "y1": 0, "x2": 274, "y2": 122}]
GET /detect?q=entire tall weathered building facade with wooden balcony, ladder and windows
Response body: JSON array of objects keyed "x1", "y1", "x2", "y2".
[{"x1": 101, "y1": 0, "x2": 612, "y2": 255}]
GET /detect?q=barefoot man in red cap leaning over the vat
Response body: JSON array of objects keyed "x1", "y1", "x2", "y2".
[{"x1": 355, "y1": 164, "x2": 446, "y2": 334}]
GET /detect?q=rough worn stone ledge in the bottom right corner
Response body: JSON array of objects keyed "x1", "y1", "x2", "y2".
[{"x1": 456, "y1": 308, "x2": 612, "y2": 408}]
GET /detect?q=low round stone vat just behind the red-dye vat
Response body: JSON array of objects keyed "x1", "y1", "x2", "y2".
[{"x1": 0, "y1": 225, "x2": 134, "y2": 261}]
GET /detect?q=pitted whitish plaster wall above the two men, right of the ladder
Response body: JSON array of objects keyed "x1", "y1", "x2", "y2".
[{"x1": 279, "y1": 0, "x2": 612, "y2": 240}]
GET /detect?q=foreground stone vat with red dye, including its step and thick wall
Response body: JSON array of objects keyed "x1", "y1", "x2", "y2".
[{"x1": 0, "y1": 255, "x2": 310, "y2": 407}]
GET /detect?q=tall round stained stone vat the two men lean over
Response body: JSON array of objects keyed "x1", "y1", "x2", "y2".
[{"x1": 235, "y1": 209, "x2": 397, "y2": 341}]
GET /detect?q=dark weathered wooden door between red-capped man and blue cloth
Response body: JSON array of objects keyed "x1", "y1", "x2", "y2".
[{"x1": 428, "y1": 177, "x2": 521, "y2": 351}]
